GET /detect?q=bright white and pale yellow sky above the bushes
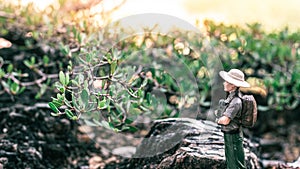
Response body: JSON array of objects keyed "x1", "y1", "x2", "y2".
[{"x1": 17, "y1": 0, "x2": 300, "y2": 30}]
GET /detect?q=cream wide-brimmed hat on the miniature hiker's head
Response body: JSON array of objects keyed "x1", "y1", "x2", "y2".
[{"x1": 219, "y1": 69, "x2": 250, "y2": 87}]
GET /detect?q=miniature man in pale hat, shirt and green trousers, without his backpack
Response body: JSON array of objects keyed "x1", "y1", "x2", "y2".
[{"x1": 216, "y1": 69, "x2": 250, "y2": 169}]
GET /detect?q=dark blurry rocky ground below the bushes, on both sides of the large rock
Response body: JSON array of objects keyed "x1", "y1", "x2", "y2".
[{"x1": 0, "y1": 97, "x2": 300, "y2": 169}]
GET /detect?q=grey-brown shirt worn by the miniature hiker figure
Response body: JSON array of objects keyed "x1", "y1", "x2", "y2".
[{"x1": 219, "y1": 92, "x2": 242, "y2": 133}]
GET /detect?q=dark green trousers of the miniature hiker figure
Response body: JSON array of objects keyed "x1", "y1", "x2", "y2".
[{"x1": 224, "y1": 131, "x2": 246, "y2": 169}]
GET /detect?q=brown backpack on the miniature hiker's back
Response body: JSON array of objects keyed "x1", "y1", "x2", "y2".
[{"x1": 239, "y1": 95, "x2": 257, "y2": 128}]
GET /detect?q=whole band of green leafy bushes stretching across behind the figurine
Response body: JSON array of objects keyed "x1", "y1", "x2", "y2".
[{"x1": 0, "y1": 1, "x2": 300, "y2": 131}]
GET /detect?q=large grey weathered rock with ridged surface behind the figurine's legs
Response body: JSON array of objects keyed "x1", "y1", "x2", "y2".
[{"x1": 130, "y1": 118, "x2": 261, "y2": 169}]
